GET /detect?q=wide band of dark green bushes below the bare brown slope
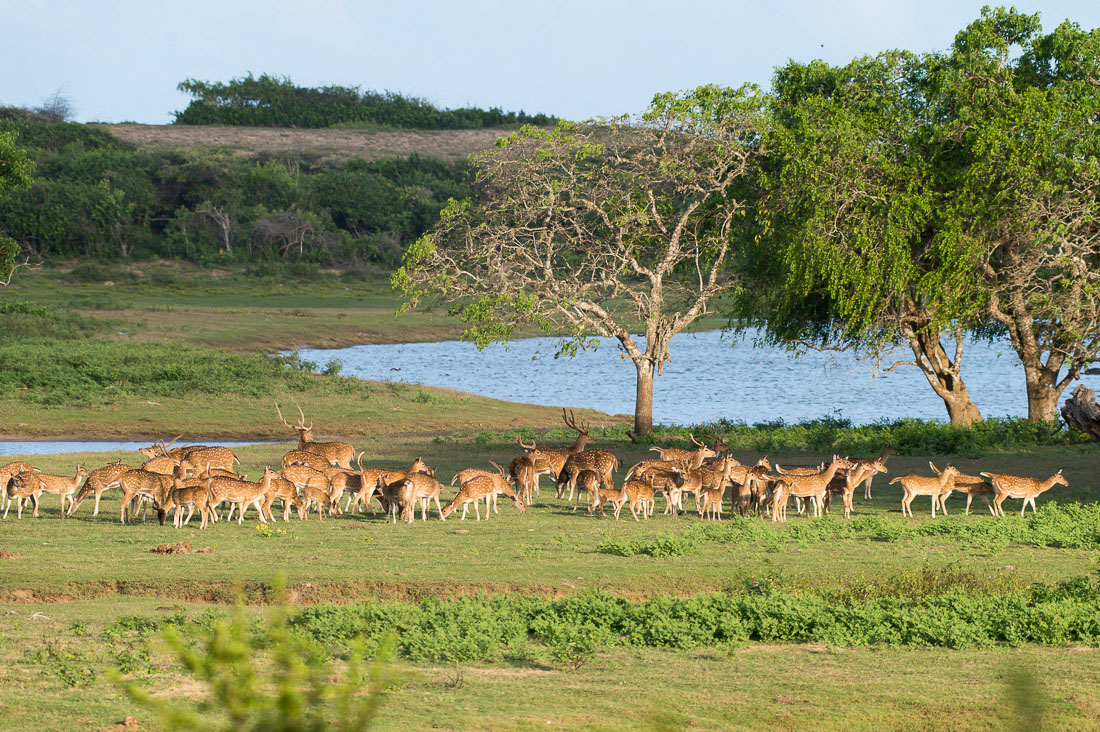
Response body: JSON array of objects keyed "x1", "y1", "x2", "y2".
[{"x1": 0, "y1": 108, "x2": 470, "y2": 267}]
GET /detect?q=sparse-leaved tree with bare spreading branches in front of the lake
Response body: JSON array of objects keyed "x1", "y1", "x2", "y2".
[{"x1": 393, "y1": 87, "x2": 763, "y2": 435}]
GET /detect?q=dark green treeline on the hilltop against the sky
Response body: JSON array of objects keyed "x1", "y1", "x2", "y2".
[{"x1": 176, "y1": 74, "x2": 557, "y2": 130}]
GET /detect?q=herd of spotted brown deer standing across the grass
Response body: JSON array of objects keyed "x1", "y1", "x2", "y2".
[{"x1": 0, "y1": 404, "x2": 1068, "y2": 528}]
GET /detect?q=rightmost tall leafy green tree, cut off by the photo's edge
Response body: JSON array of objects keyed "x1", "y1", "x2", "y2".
[{"x1": 931, "y1": 8, "x2": 1100, "y2": 422}]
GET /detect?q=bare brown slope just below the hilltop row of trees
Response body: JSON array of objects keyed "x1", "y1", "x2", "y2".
[{"x1": 98, "y1": 124, "x2": 510, "y2": 161}]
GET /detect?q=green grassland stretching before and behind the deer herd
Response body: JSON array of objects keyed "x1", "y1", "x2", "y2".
[{"x1": 0, "y1": 263, "x2": 1100, "y2": 730}]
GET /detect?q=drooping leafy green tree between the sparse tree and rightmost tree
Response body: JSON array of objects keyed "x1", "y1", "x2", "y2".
[{"x1": 756, "y1": 52, "x2": 981, "y2": 424}]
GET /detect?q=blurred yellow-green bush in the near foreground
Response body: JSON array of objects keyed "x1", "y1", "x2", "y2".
[{"x1": 112, "y1": 576, "x2": 387, "y2": 731}]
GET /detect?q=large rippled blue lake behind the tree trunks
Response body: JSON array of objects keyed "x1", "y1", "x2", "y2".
[{"x1": 292, "y1": 331, "x2": 1100, "y2": 424}]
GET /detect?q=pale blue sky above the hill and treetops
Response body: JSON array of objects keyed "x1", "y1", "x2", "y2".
[{"x1": 0, "y1": 0, "x2": 1100, "y2": 123}]
